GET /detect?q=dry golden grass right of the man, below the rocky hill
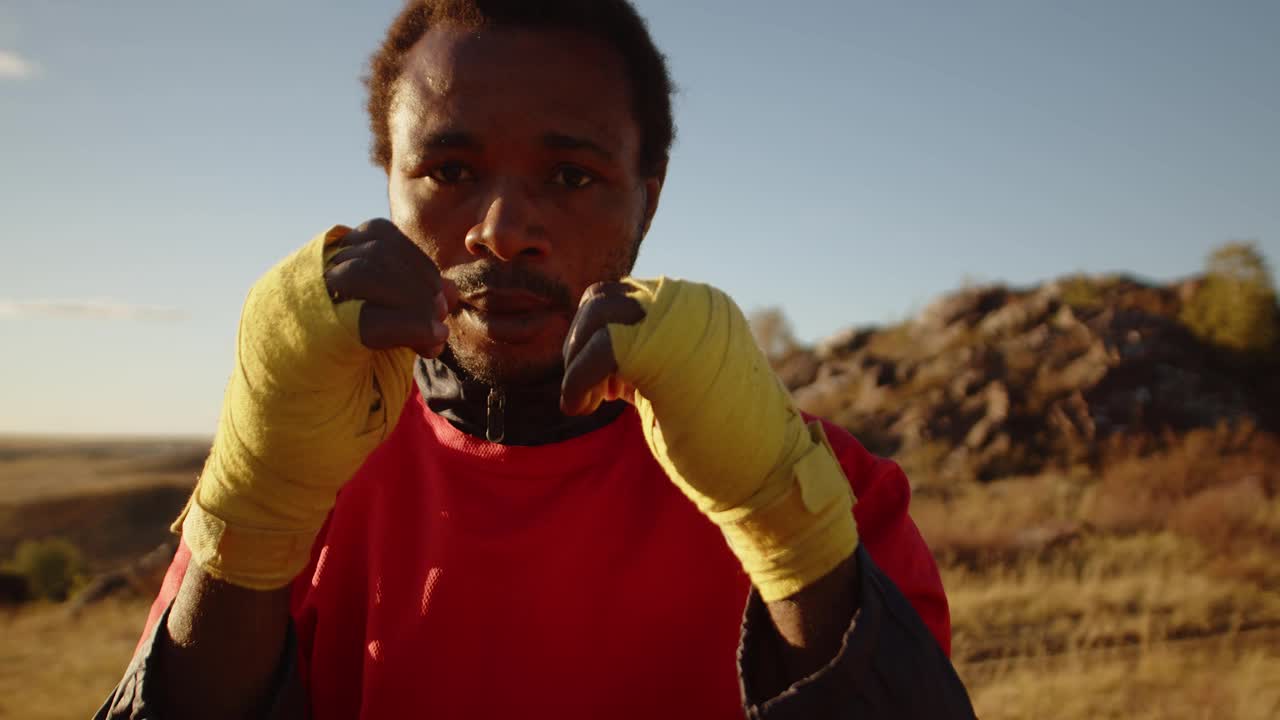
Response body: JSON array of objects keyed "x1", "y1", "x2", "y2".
[{"x1": 913, "y1": 429, "x2": 1280, "y2": 720}]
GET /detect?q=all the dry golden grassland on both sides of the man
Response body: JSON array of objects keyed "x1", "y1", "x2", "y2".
[{"x1": 0, "y1": 430, "x2": 1280, "y2": 720}]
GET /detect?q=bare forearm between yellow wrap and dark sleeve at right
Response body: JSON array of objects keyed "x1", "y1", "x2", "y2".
[{"x1": 768, "y1": 555, "x2": 859, "y2": 689}]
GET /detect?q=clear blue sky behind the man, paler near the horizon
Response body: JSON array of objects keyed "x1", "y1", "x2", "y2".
[{"x1": 0, "y1": 0, "x2": 1280, "y2": 434}]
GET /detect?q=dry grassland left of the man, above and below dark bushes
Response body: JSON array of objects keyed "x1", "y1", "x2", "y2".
[{"x1": 0, "y1": 438, "x2": 200, "y2": 719}]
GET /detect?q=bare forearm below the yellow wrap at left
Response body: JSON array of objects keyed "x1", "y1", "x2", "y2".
[{"x1": 154, "y1": 564, "x2": 289, "y2": 720}]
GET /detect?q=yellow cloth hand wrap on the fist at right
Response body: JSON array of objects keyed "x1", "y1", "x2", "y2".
[{"x1": 608, "y1": 278, "x2": 858, "y2": 602}]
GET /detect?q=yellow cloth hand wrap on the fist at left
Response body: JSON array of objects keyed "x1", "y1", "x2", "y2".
[{"x1": 174, "y1": 225, "x2": 413, "y2": 589}]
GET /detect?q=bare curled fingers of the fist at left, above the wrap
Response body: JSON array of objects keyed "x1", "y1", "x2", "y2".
[{"x1": 324, "y1": 218, "x2": 458, "y2": 357}]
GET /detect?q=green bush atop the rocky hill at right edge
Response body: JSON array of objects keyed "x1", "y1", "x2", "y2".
[{"x1": 1181, "y1": 242, "x2": 1280, "y2": 354}]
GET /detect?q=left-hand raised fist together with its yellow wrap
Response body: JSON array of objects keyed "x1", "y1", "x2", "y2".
[{"x1": 179, "y1": 220, "x2": 442, "y2": 589}]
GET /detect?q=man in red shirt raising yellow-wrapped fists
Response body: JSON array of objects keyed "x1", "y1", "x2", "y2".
[{"x1": 99, "y1": 0, "x2": 972, "y2": 719}]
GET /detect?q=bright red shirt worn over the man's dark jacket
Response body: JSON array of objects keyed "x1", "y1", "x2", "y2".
[{"x1": 143, "y1": 395, "x2": 950, "y2": 720}]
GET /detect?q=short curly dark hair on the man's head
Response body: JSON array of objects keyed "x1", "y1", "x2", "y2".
[{"x1": 364, "y1": 0, "x2": 676, "y2": 177}]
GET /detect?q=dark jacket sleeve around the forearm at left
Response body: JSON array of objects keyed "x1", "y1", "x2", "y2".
[{"x1": 93, "y1": 544, "x2": 307, "y2": 720}]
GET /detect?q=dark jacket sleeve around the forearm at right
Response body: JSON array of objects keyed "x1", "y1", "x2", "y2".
[{"x1": 739, "y1": 546, "x2": 974, "y2": 720}]
